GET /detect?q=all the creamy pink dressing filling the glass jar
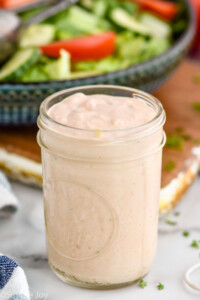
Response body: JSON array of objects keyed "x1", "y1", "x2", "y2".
[{"x1": 40, "y1": 93, "x2": 163, "y2": 287}]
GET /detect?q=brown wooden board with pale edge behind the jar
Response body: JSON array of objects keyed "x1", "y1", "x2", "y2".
[{"x1": 0, "y1": 60, "x2": 200, "y2": 212}]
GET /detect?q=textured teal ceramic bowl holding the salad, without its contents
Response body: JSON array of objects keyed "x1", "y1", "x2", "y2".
[{"x1": 0, "y1": 0, "x2": 195, "y2": 125}]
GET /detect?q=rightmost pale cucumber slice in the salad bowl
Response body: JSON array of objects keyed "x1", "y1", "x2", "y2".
[{"x1": 140, "y1": 13, "x2": 172, "y2": 39}]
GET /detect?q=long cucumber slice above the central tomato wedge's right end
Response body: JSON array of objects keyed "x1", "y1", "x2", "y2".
[{"x1": 110, "y1": 8, "x2": 151, "y2": 35}]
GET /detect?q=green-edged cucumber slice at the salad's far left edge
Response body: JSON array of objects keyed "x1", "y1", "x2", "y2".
[{"x1": 0, "y1": 48, "x2": 41, "y2": 81}]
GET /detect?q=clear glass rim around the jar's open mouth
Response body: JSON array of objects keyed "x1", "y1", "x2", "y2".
[{"x1": 38, "y1": 85, "x2": 166, "y2": 138}]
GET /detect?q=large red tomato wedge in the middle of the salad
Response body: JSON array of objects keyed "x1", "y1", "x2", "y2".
[{"x1": 40, "y1": 31, "x2": 116, "y2": 61}]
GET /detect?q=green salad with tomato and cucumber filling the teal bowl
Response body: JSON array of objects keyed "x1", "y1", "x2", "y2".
[{"x1": 0, "y1": 0, "x2": 186, "y2": 82}]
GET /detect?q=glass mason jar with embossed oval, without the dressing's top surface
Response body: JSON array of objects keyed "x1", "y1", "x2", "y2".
[{"x1": 38, "y1": 85, "x2": 166, "y2": 289}]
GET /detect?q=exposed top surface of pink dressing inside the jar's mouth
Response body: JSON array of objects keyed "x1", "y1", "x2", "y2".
[{"x1": 48, "y1": 93, "x2": 155, "y2": 130}]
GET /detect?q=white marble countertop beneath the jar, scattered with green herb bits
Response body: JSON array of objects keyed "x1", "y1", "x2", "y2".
[{"x1": 0, "y1": 177, "x2": 200, "y2": 300}]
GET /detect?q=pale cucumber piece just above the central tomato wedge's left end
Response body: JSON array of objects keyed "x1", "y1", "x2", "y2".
[{"x1": 20, "y1": 24, "x2": 55, "y2": 48}]
